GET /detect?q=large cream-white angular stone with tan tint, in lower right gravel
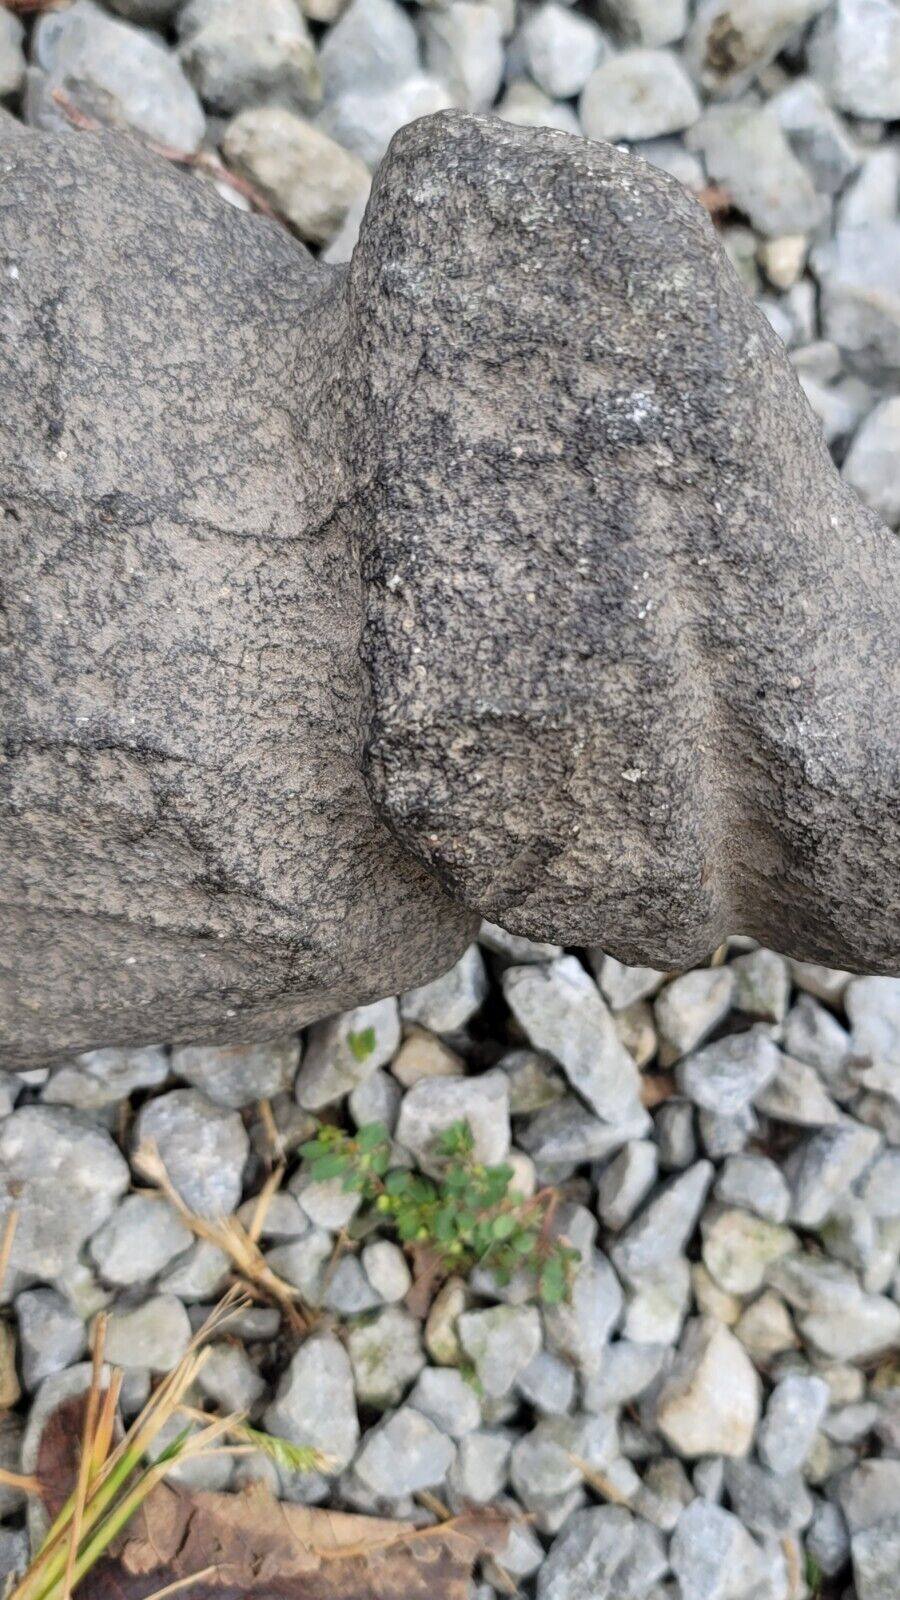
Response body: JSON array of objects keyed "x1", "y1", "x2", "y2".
[{"x1": 657, "y1": 1318, "x2": 759, "y2": 1458}]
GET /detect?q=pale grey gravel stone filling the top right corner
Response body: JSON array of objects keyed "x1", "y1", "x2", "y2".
[{"x1": 809, "y1": 0, "x2": 900, "y2": 120}]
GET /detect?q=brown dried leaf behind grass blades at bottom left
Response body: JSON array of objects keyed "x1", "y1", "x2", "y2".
[{"x1": 37, "y1": 1397, "x2": 509, "y2": 1600}]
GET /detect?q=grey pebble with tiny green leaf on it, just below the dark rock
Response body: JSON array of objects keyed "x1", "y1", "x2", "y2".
[{"x1": 295, "y1": 1000, "x2": 400, "y2": 1110}]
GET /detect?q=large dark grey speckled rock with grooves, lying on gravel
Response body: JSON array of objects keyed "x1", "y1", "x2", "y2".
[{"x1": 0, "y1": 112, "x2": 900, "y2": 1066}]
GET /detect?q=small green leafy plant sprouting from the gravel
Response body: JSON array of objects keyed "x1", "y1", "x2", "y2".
[{"x1": 301, "y1": 1122, "x2": 580, "y2": 1306}]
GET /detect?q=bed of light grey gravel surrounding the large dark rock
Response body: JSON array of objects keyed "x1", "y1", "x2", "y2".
[{"x1": 0, "y1": 0, "x2": 900, "y2": 1600}]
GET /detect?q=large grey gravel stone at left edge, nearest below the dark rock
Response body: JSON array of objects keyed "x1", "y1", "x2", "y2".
[{"x1": 0, "y1": 1106, "x2": 130, "y2": 1278}]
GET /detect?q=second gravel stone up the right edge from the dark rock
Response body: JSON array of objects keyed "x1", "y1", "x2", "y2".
[{"x1": 810, "y1": 221, "x2": 900, "y2": 384}]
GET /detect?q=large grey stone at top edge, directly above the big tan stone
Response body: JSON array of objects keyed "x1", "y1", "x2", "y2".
[{"x1": 178, "y1": 0, "x2": 322, "y2": 115}]
